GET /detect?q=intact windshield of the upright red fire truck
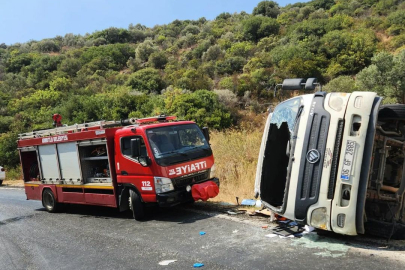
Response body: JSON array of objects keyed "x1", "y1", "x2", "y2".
[{"x1": 147, "y1": 124, "x2": 212, "y2": 166}]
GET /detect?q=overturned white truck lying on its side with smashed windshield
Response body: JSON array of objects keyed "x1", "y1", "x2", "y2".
[{"x1": 255, "y1": 78, "x2": 405, "y2": 238}]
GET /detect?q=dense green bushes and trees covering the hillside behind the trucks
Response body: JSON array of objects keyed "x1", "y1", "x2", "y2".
[{"x1": 0, "y1": 0, "x2": 405, "y2": 166}]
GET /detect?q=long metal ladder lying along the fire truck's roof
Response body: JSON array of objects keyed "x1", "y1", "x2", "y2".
[{"x1": 18, "y1": 118, "x2": 135, "y2": 140}]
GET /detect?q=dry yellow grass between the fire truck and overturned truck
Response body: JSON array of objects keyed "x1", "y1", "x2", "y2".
[{"x1": 210, "y1": 113, "x2": 265, "y2": 203}]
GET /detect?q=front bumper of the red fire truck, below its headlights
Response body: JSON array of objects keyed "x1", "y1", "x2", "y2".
[{"x1": 156, "y1": 178, "x2": 219, "y2": 207}]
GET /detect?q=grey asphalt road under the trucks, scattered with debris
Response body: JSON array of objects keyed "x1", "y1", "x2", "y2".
[{"x1": 0, "y1": 188, "x2": 405, "y2": 270}]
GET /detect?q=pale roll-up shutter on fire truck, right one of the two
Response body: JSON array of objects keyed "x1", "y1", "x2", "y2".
[{"x1": 57, "y1": 142, "x2": 82, "y2": 181}]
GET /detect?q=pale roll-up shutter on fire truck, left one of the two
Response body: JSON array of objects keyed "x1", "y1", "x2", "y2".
[{"x1": 38, "y1": 144, "x2": 60, "y2": 180}]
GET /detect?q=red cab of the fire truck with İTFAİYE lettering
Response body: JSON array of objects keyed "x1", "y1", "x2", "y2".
[{"x1": 114, "y1": 118, "x2": 219, "y2": 213}]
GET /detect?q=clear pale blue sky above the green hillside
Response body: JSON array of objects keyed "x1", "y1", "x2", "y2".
[{"x1": 0, "y1": 0, "x2": 308, "y2": 45}]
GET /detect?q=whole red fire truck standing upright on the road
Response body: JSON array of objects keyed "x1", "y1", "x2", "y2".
[{"x1": 18, "y1": 115, "x2": 219, "y2": 220}]
